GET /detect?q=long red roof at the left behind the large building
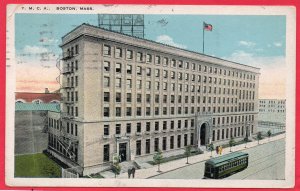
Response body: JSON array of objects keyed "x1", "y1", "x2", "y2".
[{"x1": 16, "y1": 92, "x2": 61, "y2": 103}]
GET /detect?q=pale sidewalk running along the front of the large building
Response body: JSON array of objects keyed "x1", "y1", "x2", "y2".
[{"x1": 101, "y1": 134, "x2": 285, "y2": 179}]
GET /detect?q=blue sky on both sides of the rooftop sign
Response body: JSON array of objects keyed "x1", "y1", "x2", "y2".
[{"x1": 15, "y1": 14, "x2": 286, "y2": 97}]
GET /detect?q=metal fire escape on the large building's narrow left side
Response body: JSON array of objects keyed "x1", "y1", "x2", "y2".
[{"x1": 56, "y1": 51, "x2": 78, "y2": 162}]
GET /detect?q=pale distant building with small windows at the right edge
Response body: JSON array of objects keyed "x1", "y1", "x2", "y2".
[{"x1": 258, "y1": 99, "x2": 286, "y2": 127}]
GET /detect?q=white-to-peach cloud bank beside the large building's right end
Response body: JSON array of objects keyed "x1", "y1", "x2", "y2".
[{"x1": 224, "y1": 50, "x2": 287, "y2": 99}]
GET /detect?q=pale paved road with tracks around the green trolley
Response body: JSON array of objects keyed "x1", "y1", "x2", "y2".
[{"x1": 152, "y1": 139, "x2": 285, "y2": 180}]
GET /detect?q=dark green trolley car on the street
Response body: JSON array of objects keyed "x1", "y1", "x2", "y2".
[{"x1": 204, "y1": 152, "x2": 248, "y2": 179}]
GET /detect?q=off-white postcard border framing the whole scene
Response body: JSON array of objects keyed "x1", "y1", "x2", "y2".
[{"x1": 5, "y1": 4, "x2": 296, "y2": 188}]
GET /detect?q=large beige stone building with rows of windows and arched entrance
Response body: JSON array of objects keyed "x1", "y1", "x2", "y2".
[{"x1": 49, "y1": 24, "x2": 259, "y2": 174}]
